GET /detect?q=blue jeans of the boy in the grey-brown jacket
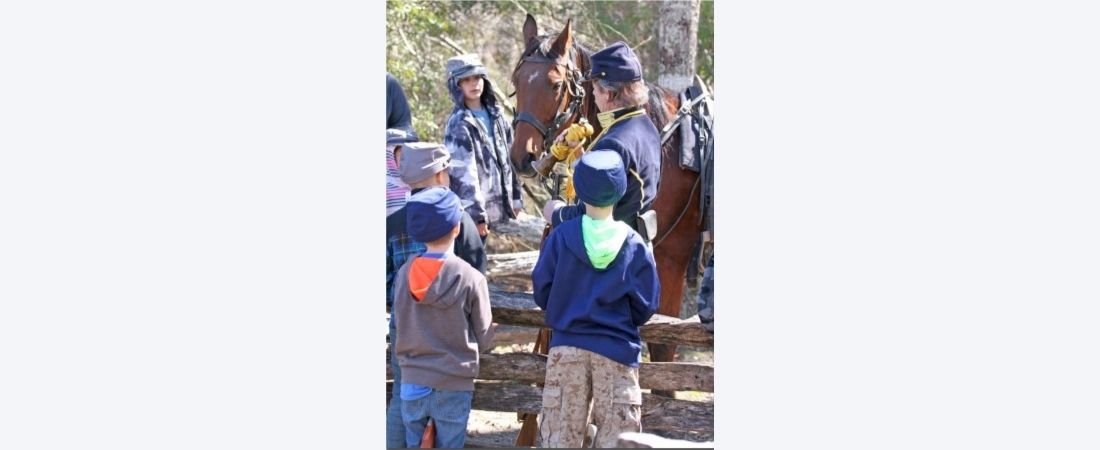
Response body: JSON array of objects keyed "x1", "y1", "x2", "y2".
[{"x1": 402, "y1": 389, "x2": 474, "y2": 449}]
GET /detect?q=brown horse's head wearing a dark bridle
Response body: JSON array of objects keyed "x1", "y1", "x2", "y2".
[{"x1": 512, "y1": 14, "x2": 587, "y2": 176}]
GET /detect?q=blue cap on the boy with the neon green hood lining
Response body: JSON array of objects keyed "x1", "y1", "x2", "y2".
[{"x1": 573, "y1": 150, "x2": 626, "y2": 207}]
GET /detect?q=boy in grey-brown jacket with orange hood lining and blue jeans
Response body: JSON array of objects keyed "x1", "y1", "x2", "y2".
[{"x1": 394, "y1": 187, "x2": 493, "y2": 448}]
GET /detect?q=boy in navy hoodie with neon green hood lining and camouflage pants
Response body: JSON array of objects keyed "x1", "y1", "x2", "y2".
[{"x1": 531, "y1": 152, "x2": 661, "y2": 448}]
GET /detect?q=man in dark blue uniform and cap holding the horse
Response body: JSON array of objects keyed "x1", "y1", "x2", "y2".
[{"x1": 543, "y1": 42, "x2": 661, "y2": 241}]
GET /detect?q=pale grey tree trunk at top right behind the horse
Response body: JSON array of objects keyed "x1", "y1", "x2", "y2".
[{"x1": 657, "y1": 0, "x2": 700, "y2": 94}]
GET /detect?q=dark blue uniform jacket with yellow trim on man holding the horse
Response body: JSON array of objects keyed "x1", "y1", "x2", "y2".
[{"x1": 552, "y1": 114, "x2": 661, "y2": 229}]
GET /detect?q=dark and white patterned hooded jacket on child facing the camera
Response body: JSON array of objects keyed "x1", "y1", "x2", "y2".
[{"x1": 443, "y1": 76, "x2": 524, "y2": 223}]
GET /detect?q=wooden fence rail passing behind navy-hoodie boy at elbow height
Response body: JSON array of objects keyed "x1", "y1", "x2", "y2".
[{"x1": 490, "y1": 286, "x2": 714, "y2": 347}]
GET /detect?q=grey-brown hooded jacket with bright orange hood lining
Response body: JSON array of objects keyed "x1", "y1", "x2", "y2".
[{"x1": 394, "y1": 254, "x2": 493, "y2": 391}]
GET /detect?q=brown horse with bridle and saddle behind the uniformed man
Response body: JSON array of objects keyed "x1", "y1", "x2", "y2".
[{"x1": 512, "y1": 14, "x2": 703, "y2": 362}]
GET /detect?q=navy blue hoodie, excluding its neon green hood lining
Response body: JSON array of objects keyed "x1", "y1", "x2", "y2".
[{"x1": 531, "y1": 216, "x2": 661, "y2": 367}]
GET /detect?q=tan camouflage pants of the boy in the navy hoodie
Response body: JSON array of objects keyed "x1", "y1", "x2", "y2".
[{"x1": 539, "y1": 347, "x2": 641, "y2": 448}]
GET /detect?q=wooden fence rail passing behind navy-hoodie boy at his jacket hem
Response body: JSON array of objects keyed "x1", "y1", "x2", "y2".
[{"x1": 477, "y1": 353, "x2": 714, "y2": 392}]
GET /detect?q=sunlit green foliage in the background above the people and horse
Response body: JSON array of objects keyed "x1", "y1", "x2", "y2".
[{"x1": 380, "y1": 0, "x2": 714, "y2": 142}]
